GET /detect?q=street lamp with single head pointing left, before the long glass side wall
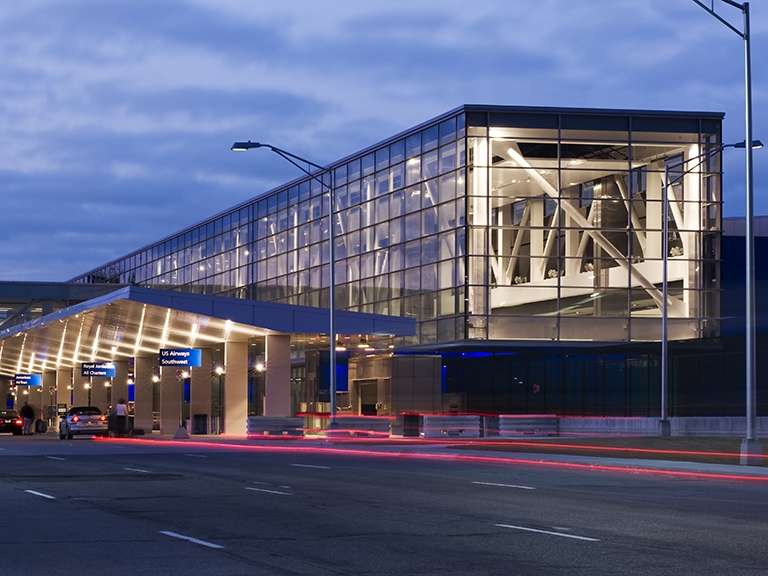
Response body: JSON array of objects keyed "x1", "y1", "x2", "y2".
[{"x1": 230, "y1": 140, "x2": 336, "y2": 428}]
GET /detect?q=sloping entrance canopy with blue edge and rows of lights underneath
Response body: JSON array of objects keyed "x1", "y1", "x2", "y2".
[{"x1": 0, "y1": 286, "x2": 416, "y2": 376}]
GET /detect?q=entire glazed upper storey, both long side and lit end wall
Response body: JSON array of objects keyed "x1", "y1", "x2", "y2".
[{"x1": 74, "y1": 106, "x2": 722, "y2": 344}]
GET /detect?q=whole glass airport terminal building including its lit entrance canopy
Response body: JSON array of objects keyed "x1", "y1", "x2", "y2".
[{"x1": 0, "y1": 105, "x2": 760, "y2": 433}]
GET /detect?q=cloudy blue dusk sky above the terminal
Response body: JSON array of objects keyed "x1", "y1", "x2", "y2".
[{"x1": 0, "y1": 0, "x2": 768, "y2": 281}]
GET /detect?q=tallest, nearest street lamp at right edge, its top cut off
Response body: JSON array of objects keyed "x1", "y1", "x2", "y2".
[{"x1": 693, "y1": 0, "x2": 762, "y2": 464}]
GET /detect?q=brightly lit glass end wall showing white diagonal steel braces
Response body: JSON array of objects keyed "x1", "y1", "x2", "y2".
[{"x1": 468, "y1": 113, "x2": 722, "y2": 341}]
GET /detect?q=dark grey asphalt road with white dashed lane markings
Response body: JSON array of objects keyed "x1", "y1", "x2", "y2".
[{"x1": 0, "y1": 437, "x2": 768, "y2": 576}]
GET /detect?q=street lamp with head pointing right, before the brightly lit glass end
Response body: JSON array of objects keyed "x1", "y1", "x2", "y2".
[{"x1": 660, "y1": 140, "x2": 763, "y2": 436}]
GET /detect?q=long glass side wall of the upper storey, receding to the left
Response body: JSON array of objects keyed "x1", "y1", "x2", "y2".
[{"x1": 74, "y1": 114, "x2": 466, "y2": 343}]
